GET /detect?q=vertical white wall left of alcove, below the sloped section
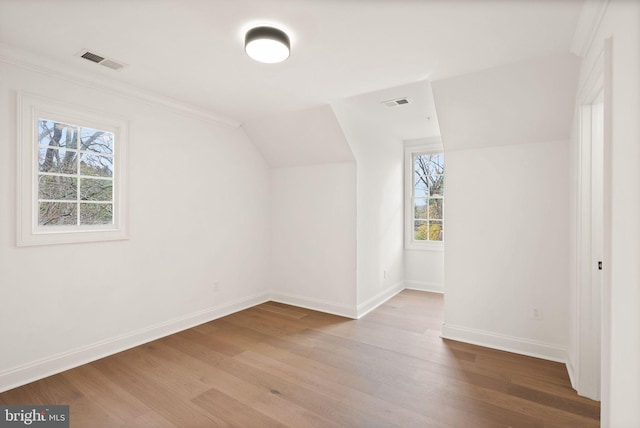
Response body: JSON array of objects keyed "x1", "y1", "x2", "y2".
[{"x1": 269, "y1": 162, "x2": 356, "y2": 317}]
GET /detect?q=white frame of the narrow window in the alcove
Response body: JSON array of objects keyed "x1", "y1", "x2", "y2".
[{"x1": 404, "y1": 137, "x2": 447, "y2": 251}]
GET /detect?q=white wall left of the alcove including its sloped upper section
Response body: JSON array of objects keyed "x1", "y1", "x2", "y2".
[{"x1": 243, "y1": 105, "x2": 357, "y2": 317}]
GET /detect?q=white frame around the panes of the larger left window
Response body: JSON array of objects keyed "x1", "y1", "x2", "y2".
[{"x1": 16, "y1": 93, "x2": 129, "y2": 246}]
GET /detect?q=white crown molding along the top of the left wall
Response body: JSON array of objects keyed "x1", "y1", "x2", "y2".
[{"x1": 0, "y1": 43, "x2": 241, "y2": 128}]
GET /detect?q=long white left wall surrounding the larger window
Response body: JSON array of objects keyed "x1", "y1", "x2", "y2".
[{"x1": 0, "y1": 62, "x2": 269, "y2": 390}]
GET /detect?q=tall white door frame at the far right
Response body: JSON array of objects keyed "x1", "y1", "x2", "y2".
[{"x1": 574, "y1": 39, "x2": 611, "y2": 400}]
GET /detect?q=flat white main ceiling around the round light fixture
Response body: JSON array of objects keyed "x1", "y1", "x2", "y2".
[{"x1": 0, "y1": 0, "x2": 583, "y2": 129}]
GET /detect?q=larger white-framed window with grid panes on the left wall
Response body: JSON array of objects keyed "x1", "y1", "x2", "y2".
[{"x1": 18, "y1": 95, "x2": 127, "y2": 245}]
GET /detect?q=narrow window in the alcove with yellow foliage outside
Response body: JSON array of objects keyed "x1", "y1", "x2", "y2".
[{"x1": 405, "y1": 141, "x2": 444, "y2": 249}]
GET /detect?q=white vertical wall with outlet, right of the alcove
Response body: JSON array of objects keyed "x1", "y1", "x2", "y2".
[{"x1": 443, "y1": 141, "x2": 569, "y2": 360}]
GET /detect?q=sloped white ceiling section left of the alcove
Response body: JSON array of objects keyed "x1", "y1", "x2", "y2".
[{"x1": 242, "y1": 105, "x2": 355, "y2": 168}]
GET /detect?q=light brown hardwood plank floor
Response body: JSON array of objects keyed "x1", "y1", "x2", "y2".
[{"x1": 0, "y1": 290, "x2": 600, "y2": 428}]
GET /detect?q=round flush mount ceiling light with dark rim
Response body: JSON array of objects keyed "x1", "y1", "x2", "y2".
[{"x1": 244, "y1": 27, "x2": 291, "y2": 64}]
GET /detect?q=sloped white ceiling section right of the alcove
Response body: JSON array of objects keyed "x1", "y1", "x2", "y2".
[{"x1": 431, "y1": 54, "x2": 580, "y2": 150}]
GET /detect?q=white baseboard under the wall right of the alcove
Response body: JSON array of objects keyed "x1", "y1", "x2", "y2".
[{"x1": 441, "y1": 324, "x2": 567, "y2": 363}]
